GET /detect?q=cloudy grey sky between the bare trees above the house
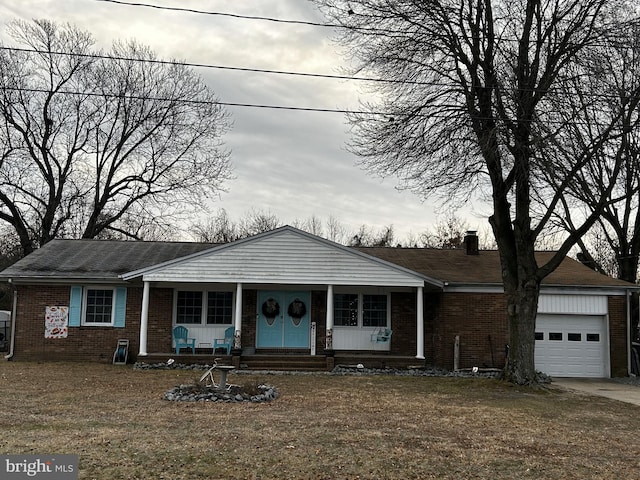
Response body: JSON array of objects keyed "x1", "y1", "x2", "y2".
[{"x1": 0, "y1": 0, "x2": 486, "y2": 240}]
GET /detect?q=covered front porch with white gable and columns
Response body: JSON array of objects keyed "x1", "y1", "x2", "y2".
[{"x1": 122, "y1": 227, "x2": 442, "y2": 368}]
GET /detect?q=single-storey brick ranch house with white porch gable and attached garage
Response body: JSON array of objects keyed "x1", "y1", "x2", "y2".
[{"x1": 0, "y1": 226, "x2": 636, "y2": 377}]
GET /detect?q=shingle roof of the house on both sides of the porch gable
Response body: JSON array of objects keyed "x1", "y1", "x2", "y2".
[{"x1": 0, "y1": 240, "x2": 632, "y2": 288}]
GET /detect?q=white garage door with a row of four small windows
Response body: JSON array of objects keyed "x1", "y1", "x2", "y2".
[{"x1": 535, "y1": 314, "x2": 609, "y2": 378}]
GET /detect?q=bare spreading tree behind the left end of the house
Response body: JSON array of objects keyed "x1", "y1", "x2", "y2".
[{"x1": 0, "y1": 20, "x2": 229, "y2": 254}]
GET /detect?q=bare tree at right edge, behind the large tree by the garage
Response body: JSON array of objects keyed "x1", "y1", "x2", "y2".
[{"x1": 558, "y1": 15, "x2": 640, "y2": 283}]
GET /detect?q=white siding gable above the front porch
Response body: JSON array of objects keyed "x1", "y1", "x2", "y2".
[{"x1": 131, "y1": 227, "x2": 425, "y2": 287}]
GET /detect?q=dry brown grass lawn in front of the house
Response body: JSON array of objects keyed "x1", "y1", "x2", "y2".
[{"x1": 0, "y1": 361, "x2": 640, "y2": 480}]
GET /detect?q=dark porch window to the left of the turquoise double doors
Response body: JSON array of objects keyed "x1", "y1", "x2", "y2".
[{"x1": 176, "y1": 290, "x2": 233, "y2": 325}]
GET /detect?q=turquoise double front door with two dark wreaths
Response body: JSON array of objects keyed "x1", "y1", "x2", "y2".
[{"x1": 256, "y1": 291, "x2": 311, "y2": 348}]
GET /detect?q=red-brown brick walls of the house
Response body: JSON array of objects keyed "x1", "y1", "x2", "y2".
[{"x1": 14, "y1": 285, "x2": 627, "y2": 376}]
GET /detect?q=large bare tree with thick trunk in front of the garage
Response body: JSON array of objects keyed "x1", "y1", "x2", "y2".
[{"x1": 315, "y1": 0, "x2": 624, "y2": 384}]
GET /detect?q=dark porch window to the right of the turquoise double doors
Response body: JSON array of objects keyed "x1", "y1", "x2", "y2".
[{"x1": 333, "y1": 293, "x2": 389, "y2": 327}]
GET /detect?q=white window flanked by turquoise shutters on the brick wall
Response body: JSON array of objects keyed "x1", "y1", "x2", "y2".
[{"x1": 69, "y1": 286, "x2": 127, "y2": 328}]
